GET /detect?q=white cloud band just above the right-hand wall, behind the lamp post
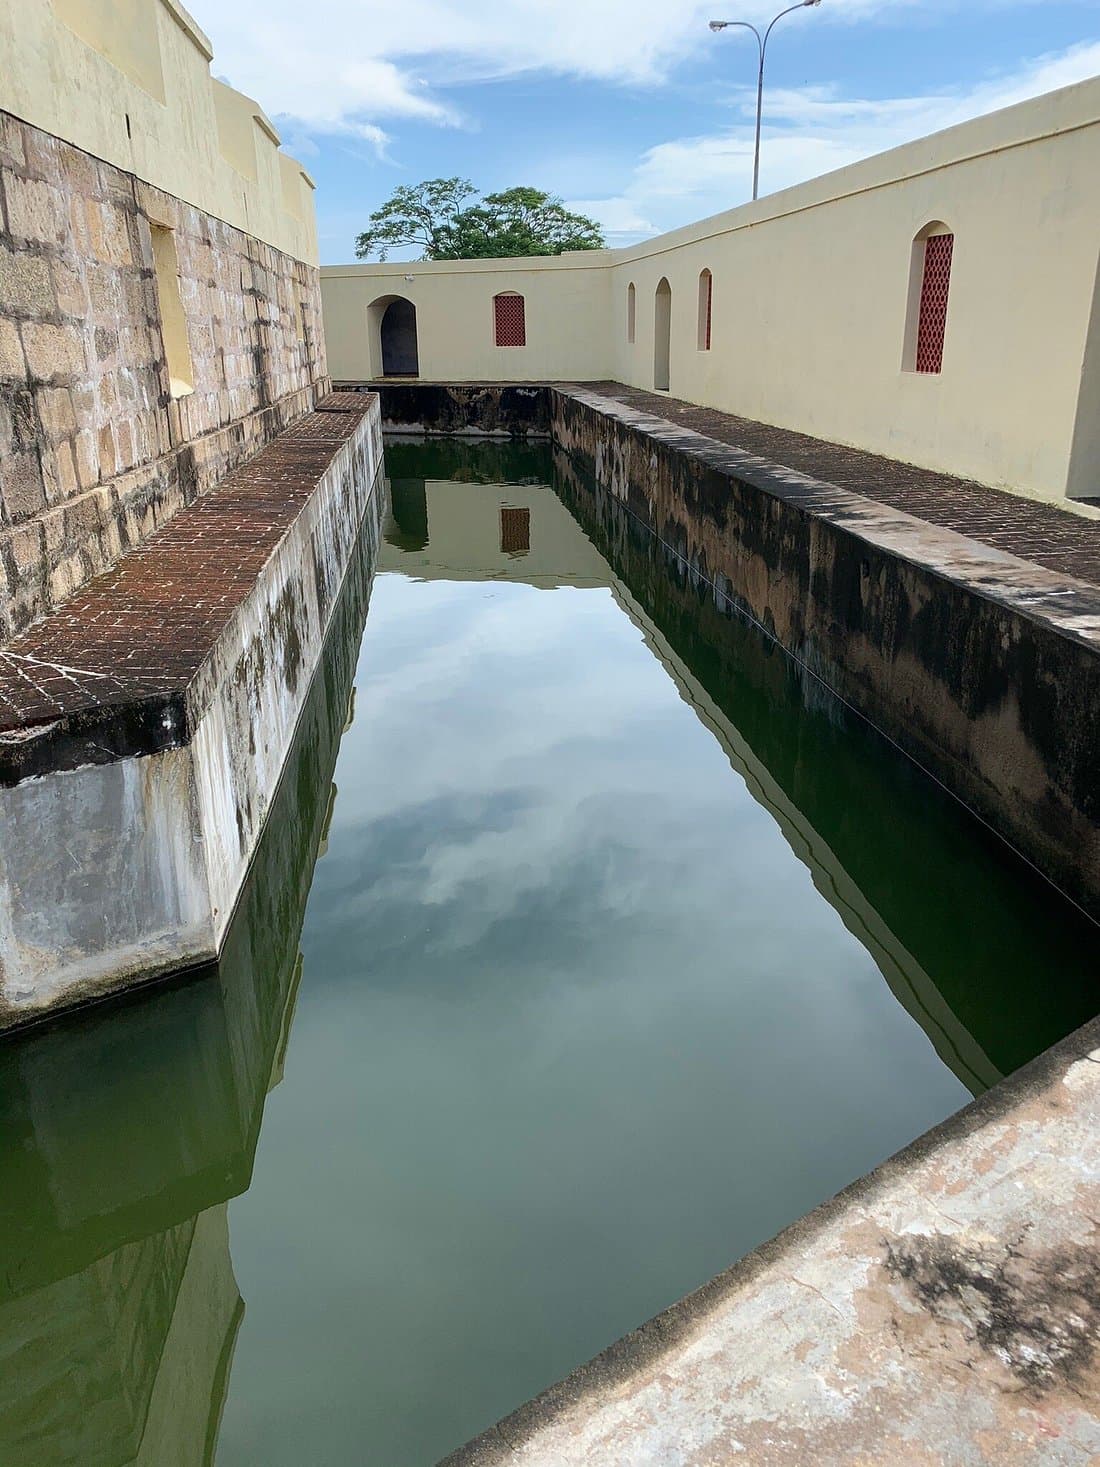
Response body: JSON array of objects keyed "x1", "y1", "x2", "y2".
[{"x1": 571, "y1": 40, "x2": 1100, "y2": 244}]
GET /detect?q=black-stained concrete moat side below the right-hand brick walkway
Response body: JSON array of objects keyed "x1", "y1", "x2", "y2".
[{"x1": 553, "y1": 390, "x2": 1100, "y2": 915}]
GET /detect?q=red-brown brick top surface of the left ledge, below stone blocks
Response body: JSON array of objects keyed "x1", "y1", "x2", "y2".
[{"x1": 0, "y1": 392, "x2": 374, "y2": 785}]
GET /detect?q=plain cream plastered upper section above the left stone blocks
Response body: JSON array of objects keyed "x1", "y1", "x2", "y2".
[{"x1": 0, "y1": 0, "x2": 317, "y2": 264}]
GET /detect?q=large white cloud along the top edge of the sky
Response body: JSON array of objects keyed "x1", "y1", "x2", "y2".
[{"x1": 189, "y1": 0, "x2": 1079, "y2": 148}]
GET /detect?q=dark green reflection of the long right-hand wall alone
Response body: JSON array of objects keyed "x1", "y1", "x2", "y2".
[{"x1": 554, "y1": 449, "x2": 1100, "y2": 1094}]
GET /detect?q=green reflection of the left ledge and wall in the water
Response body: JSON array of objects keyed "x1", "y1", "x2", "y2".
[{"x1": 0, "y1": 503, "x2": 384, "y2": 1467}]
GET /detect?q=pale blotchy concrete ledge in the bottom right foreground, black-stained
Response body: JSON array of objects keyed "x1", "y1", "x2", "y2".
[{"x1": 444, "y1": 1021, "x2": 1100, "y2": 1467}]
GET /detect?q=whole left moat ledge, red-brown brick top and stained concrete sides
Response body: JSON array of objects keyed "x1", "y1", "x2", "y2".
[{"x1": 0, "y1": 395, "x2": 381, "y2": 1028}]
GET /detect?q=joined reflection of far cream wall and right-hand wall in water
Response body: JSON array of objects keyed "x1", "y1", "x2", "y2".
[{"x1": 383, "y1": 440, "x2": 1097, "y2": 1094}]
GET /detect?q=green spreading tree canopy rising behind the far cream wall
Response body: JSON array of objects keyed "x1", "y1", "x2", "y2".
[{"x1": 355, "y1": 178, "x2": 604, "y2": 260}]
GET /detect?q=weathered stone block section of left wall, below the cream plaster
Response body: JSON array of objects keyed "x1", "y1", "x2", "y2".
[{"x1": 0, "y1": 113, "x2": 327, "y2": 641}]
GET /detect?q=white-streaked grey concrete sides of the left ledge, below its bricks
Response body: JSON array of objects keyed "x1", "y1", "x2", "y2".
[{"x1": 0, "y1": 403, "x2": 381, "y2": 1027}]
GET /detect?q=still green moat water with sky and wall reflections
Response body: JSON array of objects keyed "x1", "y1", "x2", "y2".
[{"x1": 0, "y1": 443, "x2": 1099, "y2": 1467}]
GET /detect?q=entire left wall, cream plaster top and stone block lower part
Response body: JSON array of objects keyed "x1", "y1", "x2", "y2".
[{"x1": 0, "y1": 0, "x2": 329, "y2": 643}]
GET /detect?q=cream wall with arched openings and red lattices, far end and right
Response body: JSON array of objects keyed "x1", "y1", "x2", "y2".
[{"x1": 321, "y1": 79, "x2": 1100, "y2": 499}]
